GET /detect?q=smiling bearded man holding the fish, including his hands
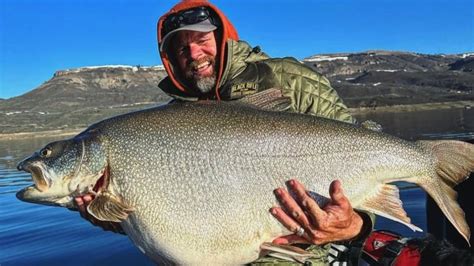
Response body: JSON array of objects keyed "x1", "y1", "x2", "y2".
[{"x1": 76, "y1": 1, "x2": 372, "y2": 263}]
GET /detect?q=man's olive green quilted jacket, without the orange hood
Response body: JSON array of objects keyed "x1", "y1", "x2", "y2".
[{"x1": 159, "y1": 40, "x2": 355, "y2": 123}]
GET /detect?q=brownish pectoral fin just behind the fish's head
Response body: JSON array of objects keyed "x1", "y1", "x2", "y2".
[{"x1": 87, "y1": 191, "x2": 134, "y2": 222}]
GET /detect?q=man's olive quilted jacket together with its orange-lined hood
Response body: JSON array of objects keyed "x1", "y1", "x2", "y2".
[{"x1": 157, "y1": 0, "x2": 355, "y2": 123}]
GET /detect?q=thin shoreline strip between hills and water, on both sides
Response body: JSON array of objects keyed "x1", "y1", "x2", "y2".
[{"x1": 0, "y1": 101, "x2": 474, "y2": 141}]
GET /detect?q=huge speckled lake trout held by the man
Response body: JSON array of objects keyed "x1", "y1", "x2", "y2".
[{"x1": 17, "y1": 95, "x2": 474, "y2": 264}]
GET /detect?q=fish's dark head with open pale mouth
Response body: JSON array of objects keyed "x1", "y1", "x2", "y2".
[{"x1": 16, "y1": 137, "x2": 107, "y2": 208}]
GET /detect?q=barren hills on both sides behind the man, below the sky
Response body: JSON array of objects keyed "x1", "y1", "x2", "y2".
[{"x1": 0, "y1": 51, "x2": 474, "y2": 134}]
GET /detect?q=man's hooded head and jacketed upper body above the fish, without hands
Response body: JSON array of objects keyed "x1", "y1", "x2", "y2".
[{"x1": 158, "y1": 1, "x2": 355, "y2": 122}]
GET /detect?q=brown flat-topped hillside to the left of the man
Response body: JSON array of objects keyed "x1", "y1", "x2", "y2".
[{"x1": 0, "y1": 66, "x2": 169, "y2": 133}]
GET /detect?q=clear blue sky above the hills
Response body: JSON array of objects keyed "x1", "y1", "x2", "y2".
[{"x1": 0, "y1": 0, "x2": 474, "y2": 98}]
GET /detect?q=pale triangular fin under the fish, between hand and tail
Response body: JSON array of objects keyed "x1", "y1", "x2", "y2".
[{"x1": 361, "y1": 184, "x2": 423, "y2": 232}]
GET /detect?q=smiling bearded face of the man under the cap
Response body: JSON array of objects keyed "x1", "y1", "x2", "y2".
[{"x1": 174, "y1": 30, "x2": 217, "y2": 93}]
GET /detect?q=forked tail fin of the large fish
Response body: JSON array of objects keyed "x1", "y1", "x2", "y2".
[{"x1": 412, "y1": 140, "x2": 474, "y2": 244}]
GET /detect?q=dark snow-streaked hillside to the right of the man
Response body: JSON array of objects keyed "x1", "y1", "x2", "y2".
[{"x1": 303, "y1": 51, "x2": 474, "y2": 107}]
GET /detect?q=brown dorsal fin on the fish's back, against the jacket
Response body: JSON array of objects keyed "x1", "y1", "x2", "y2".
[{"x1": 239, "y1": 88, "x2": 291, "y2": 111}]
